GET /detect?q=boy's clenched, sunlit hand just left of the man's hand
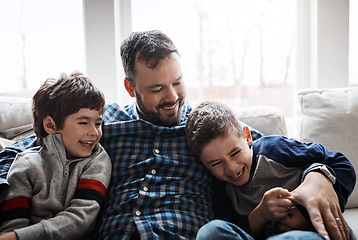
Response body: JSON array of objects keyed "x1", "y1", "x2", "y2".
[{"x1": 257, "y1": 187, "x2": 292, "y2": 222}]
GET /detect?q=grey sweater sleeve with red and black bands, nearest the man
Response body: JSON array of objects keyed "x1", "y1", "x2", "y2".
[{"x1": 15, "y1": 147, "x2": 112, "y2": 240}]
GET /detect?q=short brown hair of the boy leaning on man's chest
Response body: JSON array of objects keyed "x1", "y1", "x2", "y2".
[{"x1": 185, "y1": 101, "x2": 245, "y2": 156}]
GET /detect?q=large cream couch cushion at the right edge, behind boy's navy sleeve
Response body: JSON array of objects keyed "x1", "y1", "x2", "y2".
[{"x1": 296, "y1": 88, "x2": 358, "y2": 208}]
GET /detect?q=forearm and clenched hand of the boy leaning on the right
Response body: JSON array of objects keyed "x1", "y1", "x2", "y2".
[{"x1": 248, "y1": 187, "x2": 292, "y2": 237}]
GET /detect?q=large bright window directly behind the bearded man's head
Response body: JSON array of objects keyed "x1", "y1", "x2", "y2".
[{"x1": 132, "y1": 0, "x2": 295, "y2": 133}]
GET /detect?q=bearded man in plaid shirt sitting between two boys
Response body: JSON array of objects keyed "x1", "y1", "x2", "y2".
[{"x1": 0, "y1": 31, "x2": 355, "y2": 239}]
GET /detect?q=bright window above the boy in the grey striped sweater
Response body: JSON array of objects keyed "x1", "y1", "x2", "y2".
[{"x1": 0, "y1": 0, "x2": 85, "y2": 97}]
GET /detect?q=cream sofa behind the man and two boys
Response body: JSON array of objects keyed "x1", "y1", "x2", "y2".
[{"x1": 0, "y1": 88, "x2": 358, "y2": 236}]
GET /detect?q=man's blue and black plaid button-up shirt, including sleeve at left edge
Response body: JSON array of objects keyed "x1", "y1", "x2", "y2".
[{"x1": 0, "y1": 102, "x2": 260, "y2": 239}]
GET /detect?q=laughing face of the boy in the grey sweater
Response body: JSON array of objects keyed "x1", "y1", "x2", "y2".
[{"x1": 57, "y1": 108, "x2": 103, "y2": 159}]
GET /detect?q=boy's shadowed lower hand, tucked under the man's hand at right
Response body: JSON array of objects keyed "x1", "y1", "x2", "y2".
[{"x1": 279, "y1": 206, "x2": 312, "y2": 232}]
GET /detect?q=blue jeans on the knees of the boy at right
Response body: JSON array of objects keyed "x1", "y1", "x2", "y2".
[{"x1": 196, "y1": 220, "x2": 325, "y2": 240}]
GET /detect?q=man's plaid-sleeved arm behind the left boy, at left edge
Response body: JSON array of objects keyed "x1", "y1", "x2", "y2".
[{"x1": 0, "y1": 135, "x2": 37, "y2": 202}]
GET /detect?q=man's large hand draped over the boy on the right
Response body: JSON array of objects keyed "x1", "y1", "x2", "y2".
[{"x1": 292, "y1": 172, "x2": 349, "y2": 240}]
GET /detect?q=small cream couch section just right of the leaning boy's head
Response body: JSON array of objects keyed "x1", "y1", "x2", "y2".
[{"x1": 236, "y1": 106, "x2": 287, "y2": 136}]
